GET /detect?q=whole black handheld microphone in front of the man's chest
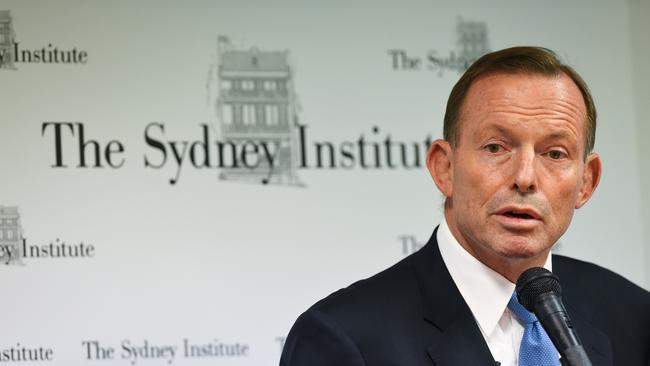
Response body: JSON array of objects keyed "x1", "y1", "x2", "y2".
[{"x1": 515, "y1": 267, "x2": 592, "y2": 366}]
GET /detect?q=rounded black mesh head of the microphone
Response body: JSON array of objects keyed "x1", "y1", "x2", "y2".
[{"x1": 515, "y1": 267, "x2": 562, "y2": 313}]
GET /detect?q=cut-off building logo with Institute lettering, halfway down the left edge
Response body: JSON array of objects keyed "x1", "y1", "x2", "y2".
[{"x1": 0, "y1": 205, "x2": 95, "y2": 266}]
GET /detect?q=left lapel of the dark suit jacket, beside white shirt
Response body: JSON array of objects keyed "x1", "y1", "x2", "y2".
[{"x1": 412, "y1": 229, "x2": 495, "y2": 366}]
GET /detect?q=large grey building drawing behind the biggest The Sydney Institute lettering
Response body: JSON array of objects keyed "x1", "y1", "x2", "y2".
[{"x1": 216, "y1": 37, "x2": 302, "y2": 185}]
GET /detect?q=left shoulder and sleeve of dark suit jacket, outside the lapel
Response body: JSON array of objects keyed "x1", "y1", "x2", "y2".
[{"x1": 281, "y1": 249, "x2": 428, "y2": 366}]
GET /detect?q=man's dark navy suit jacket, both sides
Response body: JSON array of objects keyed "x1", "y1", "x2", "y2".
[{"x1": 280, "y1": 232, "x2": 650, "y2": 366}]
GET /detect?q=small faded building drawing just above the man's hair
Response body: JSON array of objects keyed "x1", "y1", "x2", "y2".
[{"x1": 428, "y1": 17, "x2": 490, "y2": 76}]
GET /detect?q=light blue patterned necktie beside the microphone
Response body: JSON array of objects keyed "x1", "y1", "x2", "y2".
[{"x1": 508, "y1": 293, "x2": 560, "y2": 366}]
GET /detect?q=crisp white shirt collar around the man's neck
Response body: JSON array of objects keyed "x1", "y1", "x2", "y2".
[{"x1": 436, "y1": 216, "x2": 551, "y2": 335}]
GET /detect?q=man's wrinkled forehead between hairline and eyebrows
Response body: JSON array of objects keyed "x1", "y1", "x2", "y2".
[{"x1": 460, "y1": 73, "x2": 587, "y2": 138}]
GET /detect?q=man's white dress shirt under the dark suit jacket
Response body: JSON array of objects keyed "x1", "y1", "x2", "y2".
[{"x1": 436, "y1": 217, "x2": 551, "y2": 366}]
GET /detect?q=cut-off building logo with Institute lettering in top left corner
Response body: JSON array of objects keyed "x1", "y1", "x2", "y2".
[{"x1": 0, "y1": 10, "x2": 88, "y2": 70}]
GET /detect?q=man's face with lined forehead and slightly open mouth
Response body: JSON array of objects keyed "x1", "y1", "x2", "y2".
[{"x1": 429, "y1": 74, "x2": 600, "y2": 277}]
